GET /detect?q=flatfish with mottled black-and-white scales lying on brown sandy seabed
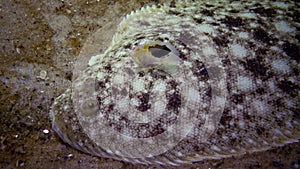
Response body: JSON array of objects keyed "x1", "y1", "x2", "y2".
[{"x1": 51, "y1": 1, "x2": 300, "y2": 165}]
